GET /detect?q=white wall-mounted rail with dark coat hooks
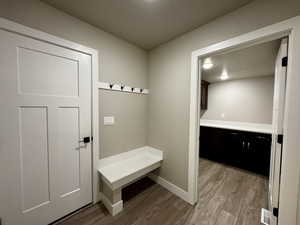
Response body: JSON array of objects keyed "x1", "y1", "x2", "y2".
[{"x1": 98, "y1": 82, "x2": 149, "y2": 95}]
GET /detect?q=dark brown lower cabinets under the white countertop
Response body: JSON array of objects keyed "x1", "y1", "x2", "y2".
[{"x1": 200, "y1": 127, "x2": 272, "y2": 176}]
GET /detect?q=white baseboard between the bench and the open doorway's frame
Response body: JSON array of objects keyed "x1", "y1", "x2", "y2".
[{"x1": 148, "y1": 173, "x2": 190, "y2": 203}]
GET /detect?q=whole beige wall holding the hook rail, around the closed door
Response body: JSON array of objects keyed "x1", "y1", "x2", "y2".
[{"x1": 0, "y1": 0, "x2": 148, "y2": 156}]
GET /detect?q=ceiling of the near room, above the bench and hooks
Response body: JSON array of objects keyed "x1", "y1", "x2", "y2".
[{"x1": 42, "y1": 0, "x2": 252, "y2": 50}]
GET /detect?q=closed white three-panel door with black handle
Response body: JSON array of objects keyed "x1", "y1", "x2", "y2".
[{"x1": 0, "y1": 30, "x2": 92, "y2": 225}]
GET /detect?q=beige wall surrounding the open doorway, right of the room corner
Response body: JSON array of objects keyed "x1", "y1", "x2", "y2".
[{"x1": 148, "y1": 0, "x2": 300, "y2": 190}]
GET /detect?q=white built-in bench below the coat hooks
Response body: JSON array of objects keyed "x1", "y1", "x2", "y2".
[{"x1": 98, "y1": 146, "x2": 163, "y2": 215}]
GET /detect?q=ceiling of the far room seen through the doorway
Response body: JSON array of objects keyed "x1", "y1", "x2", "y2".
[{"x1": 202, "y1": 40, "x2": 280, "y2": 83}]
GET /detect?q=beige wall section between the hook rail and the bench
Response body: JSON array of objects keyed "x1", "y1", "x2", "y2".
[{"x1": 99, "y1": 90, "x2": 148, "y2": 157}]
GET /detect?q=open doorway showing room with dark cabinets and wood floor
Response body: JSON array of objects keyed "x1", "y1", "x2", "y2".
[{"x1": 192, "y1": 37, "x2": 288, "y2": 225}]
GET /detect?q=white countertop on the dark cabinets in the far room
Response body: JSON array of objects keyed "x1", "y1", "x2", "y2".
[{"x1": 200, "y1": 119, "x2": 272, "y2": 134}]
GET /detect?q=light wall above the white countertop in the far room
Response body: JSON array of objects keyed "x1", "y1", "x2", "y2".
[{"x1": 201, "y1": 76, "x2": 274, "y2": 124}]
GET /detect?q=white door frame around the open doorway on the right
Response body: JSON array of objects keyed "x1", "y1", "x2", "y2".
[{"x1": 188, "y1": 16, "x2": 300, "y2": 225}]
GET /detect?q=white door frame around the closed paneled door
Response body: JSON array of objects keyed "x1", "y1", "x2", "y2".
[{"x1": 0, "y1": 17, "x2": 100, "y2": 203}]
